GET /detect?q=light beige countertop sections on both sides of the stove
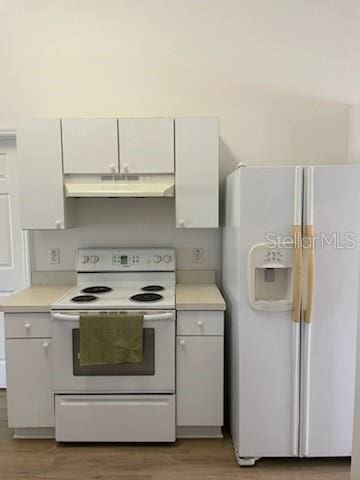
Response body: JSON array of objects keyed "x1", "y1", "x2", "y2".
[{"x1": 0, "y1": 283, "x2": 225, "y2": 313}]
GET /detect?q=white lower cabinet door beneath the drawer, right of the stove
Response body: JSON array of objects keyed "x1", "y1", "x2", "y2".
[{"x1": 176, "y1": 336, "x2": 224, "y2": 426}]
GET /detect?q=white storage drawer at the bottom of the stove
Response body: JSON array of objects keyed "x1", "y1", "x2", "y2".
[{"x1": 55, "y1": 395, "x2": 175, "y2": 442}]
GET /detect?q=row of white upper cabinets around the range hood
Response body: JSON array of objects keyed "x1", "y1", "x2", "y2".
[{"x1": 17, "y1": 117, "x2": 219, "y2": 229}]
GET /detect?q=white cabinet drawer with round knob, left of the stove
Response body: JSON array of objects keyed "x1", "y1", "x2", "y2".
[{"x1": 5, "y1": 313, "x2": 52, "y2": 338}]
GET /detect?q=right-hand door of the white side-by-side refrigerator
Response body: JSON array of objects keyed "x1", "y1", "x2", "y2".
[{"x1": 300, "y1": 165, "x2": 360, "y2": 457}]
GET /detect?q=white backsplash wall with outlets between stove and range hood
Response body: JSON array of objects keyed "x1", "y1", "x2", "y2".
[{"x1": 28, "y1": 198, "x2": 220, "y2": 270}]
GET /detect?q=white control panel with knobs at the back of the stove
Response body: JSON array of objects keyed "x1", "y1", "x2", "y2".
[{"x1": 77, "y1": 248, "x2": 175, "y2": 272}]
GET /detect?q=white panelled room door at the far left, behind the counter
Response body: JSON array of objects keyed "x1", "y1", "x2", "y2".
[{"x1": 0, "y1": 133, "x2": 26, "y2": 388}]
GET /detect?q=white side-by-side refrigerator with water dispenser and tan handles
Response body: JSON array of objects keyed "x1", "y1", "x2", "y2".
[{"x1": 223, "y1": 165, "x2": 360, "y2": 465}]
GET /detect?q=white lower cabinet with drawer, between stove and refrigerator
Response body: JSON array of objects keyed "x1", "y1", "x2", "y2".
[{"x1": 176, "y1": 312, "x2": 224, "y2": 437}]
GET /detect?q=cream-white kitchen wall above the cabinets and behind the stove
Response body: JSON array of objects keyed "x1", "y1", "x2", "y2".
[{"x1": 0, "y1": 0, "x2": 354, "y2": 269}]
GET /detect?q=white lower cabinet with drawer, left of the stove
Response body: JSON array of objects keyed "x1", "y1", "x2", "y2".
[{"x1": 5, "y1": 313, "x2": 55, "y2": 438}]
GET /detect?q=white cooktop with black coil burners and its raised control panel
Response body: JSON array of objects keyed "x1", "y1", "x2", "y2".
[{"x1": 52, "y1": 248, "x2": 175, "y2": 311}]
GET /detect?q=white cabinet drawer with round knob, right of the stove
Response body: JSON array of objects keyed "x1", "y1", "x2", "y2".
[{"x1": 177, "y1": 311, "x2": 224, "y2": 336}]
